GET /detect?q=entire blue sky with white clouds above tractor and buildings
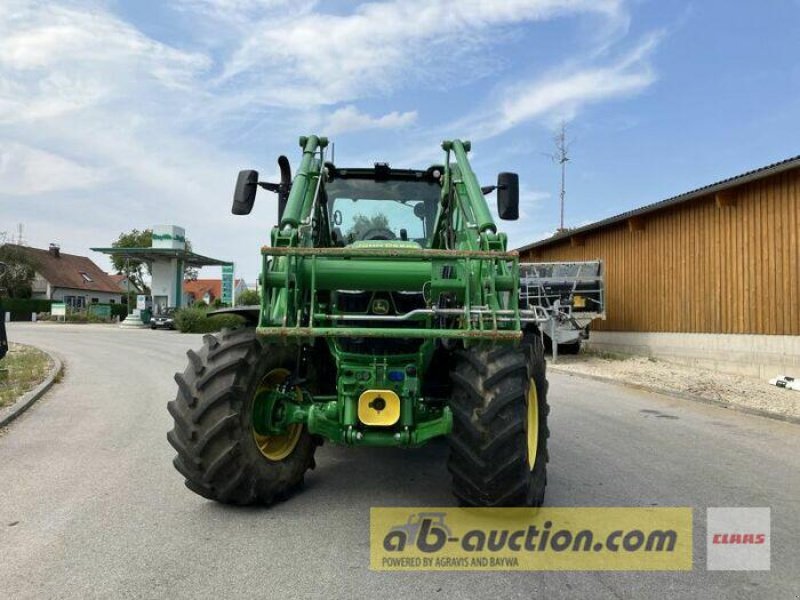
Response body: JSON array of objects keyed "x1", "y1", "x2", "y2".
[{"x1": 0, "y1": 0, "x2": 800, "y2": 284}]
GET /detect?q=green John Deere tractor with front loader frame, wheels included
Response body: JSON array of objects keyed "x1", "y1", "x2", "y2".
[{"x1": 168, "y1": 135, "x2": 548, "y2": 506}]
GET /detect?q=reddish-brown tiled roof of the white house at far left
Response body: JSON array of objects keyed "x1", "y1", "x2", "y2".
[{"x1": 8, "y1": 246, "x2": 121, "y2": 294}]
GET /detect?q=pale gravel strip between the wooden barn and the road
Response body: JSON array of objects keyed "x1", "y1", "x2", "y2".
[{"x1": 548, "y1": 352, "x2": 800, "y2": 419}]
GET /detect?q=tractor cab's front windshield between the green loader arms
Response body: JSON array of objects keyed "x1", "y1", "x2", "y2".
[{"x1": 326, "y1": 178, "x2": 441, "y2": 246}]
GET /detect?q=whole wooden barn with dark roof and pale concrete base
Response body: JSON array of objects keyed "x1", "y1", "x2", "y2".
[{"x1": 519, "y1": 156, "x2": 800, "y2": 376}]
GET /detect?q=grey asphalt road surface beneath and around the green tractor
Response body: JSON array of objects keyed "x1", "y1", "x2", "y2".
[{"x1": 0, "y1": 323, "x2": 800, "y2": 599}]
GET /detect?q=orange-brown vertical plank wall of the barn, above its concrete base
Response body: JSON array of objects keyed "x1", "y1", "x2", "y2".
[{"x1": 521, "y1": 169, "x2": 800, "y2": 335}]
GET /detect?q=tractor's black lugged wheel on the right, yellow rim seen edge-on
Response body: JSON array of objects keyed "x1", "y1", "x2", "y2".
[{"x1": 448, "y1": 338, "x2": 549, "y2": 506}]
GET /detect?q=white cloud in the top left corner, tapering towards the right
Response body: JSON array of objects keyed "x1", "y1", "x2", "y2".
[{"x1": 0, "y1": 2, "x2": 209, "y2": 123}]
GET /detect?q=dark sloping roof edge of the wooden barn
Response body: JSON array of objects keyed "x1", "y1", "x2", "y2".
[{"x1": 517, "y1": 155, "x2": 800, "y2": 252}]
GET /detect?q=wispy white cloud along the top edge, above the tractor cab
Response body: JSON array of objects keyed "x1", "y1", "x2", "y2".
[{"x1": 217, "y1": 0, "x2": 623, "y2": 106}]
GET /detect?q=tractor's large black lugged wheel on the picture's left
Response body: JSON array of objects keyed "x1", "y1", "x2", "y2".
[{"x1": 167, "y1": 328, "x2": 316, "y2": 504}]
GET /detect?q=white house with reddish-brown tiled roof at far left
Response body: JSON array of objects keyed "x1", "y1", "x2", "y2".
[{"x1": 11, "y1": 244, "x2": 122, "y2": 310}]
